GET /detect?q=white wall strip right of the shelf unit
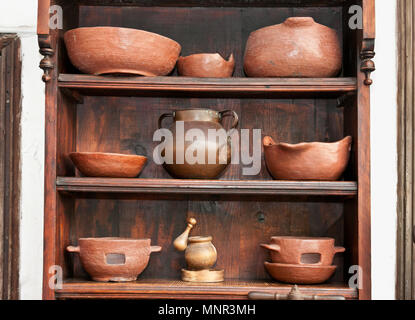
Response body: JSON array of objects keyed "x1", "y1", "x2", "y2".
[{"x1": 371, "y1": 0, "x2": 400, "y2": 299}]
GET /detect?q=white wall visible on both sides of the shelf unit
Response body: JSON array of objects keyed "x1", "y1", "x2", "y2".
[{"x1": 0, "y1": 0, "x2": 397, "y2": 299}]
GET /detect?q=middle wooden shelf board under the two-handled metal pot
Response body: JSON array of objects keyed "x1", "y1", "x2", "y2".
[{"x1": 56, "y1": 177, "x2": 357, "y2": 196}]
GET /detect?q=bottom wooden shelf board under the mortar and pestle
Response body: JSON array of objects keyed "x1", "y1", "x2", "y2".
[{"x1": 55, "y1": 279, "x2": 358, "y2": 300}]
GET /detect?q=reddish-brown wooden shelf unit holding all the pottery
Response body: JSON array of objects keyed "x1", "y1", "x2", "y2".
[{"x1": 38, "y1": 0, "x2": 375, "y2": 300}]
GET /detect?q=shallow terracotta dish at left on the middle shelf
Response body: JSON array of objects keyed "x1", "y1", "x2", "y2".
[{"x1": 69, "y1": 152, "x2": 147, "y2": 178}]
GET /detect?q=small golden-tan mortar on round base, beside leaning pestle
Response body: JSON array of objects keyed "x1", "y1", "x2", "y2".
[{"x1": 185, "y1": 237, "x2": 218, "y2": 270}]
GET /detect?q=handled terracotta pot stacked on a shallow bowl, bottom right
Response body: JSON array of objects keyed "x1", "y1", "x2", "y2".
[{"x1": 261, "y1": 237, "x2": 345, "y2": 266}]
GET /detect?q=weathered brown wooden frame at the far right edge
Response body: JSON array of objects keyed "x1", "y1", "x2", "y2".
[{"x1": 397, "y1": 0, "x2": 415, "y2": 300}]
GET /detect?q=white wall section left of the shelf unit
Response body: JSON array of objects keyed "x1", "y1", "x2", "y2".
[{"x1": 0, "y1": 0, "x2": 45, "y2": 299}]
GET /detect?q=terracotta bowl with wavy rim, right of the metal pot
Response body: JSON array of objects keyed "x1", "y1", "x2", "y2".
[{"x1": 263, "y1": 137, "x2": 352, "y2": 181}]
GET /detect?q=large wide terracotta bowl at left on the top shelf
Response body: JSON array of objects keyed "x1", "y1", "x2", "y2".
[{"x1": 64, "y1": 27, "x2": 181, "y2": 77}]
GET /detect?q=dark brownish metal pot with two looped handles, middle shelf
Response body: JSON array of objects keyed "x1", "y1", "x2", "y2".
[{"x1": 159, "y1": 109, "x2": 239, "y2": 179}]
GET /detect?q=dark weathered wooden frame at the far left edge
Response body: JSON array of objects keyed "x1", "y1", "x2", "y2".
[{"x1": 0, "y1": 34, "x2": 21, "y2": 300}]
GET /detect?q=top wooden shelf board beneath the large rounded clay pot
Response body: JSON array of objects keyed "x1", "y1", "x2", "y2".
[{"x1": 58, "y1": 74, "x2": 357, "y2": 98}]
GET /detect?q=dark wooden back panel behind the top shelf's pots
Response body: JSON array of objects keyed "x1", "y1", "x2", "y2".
[{"x1": 79, "y1": 6, "x2": 343, "y2": 77}]
